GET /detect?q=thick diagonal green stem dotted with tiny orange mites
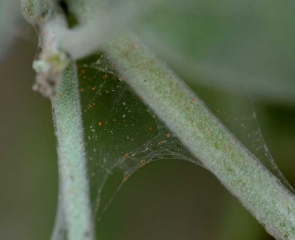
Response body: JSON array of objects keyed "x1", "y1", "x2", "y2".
[{"x1": 107, "y1": 33, "x2": 295, "y2": 240}]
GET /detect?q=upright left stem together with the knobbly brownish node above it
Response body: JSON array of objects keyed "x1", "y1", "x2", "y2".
[{"x1": 22, "y1": 0, "x2": 95, "y2": 240}]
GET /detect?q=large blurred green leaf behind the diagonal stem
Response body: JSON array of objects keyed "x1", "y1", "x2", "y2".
[{"x1": 134, "y1": 0, "x2": 295, "y2": 105}]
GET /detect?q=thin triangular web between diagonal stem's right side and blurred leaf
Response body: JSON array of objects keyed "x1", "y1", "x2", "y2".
[{"x1": 202, "y1": 86, "x2": 294, "y2": 193}]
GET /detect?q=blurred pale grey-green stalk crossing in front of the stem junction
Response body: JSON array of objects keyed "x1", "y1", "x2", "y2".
[{"x1": 58, "y1": 0, "x2": 158, "y2": 60}]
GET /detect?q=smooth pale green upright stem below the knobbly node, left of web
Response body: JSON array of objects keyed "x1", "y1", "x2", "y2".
[{"x1": 52, "y1": 64, "x2": 95, "y2": 240}]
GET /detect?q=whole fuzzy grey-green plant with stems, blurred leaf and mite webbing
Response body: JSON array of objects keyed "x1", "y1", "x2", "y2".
[{"x1": 2, "y1": 0, "x2": 295, "y2": 240}]
